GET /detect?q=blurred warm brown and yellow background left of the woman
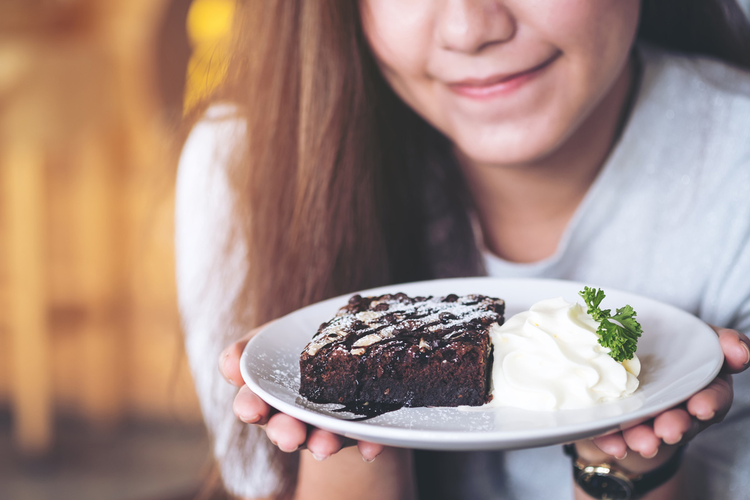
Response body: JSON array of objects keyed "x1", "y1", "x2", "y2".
[{"x1": 0, "y1": 0, "x2": 233, "y2": 500}]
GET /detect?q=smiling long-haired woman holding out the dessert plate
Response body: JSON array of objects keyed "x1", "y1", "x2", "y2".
[{"x1": 177, "y1": 0, "x2": 750, "y2": 499}]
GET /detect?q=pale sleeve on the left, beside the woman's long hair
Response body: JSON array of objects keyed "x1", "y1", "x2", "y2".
[{"x1": 175, "y1": 106, "x2": 281, "y2": 498}]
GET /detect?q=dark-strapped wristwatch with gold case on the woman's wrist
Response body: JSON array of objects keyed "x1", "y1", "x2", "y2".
[{"x1": 563, "y1": 444, "x2": 685, "y2": 500}]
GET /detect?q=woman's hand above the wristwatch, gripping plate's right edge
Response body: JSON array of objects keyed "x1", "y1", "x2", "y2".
[{"x1": 592, "y1": 327, "x2": 750, "y2": 459}]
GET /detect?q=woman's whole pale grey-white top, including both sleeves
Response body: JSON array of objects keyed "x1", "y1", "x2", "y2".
[{"x1": 176, "y1": 46, "x2": 750, "y2": 500}]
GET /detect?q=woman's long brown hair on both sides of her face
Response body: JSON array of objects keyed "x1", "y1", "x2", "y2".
[{"x1": 192, "y1": 0, "x2": 750, "y2": 496}]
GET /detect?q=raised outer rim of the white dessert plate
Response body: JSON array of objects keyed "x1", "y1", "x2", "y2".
[{"x1": 240, "y1": 277, "x2": 723, "y2": 451}]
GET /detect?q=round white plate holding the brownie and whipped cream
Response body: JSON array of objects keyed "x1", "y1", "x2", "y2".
[{"x1": 240, "y1": 278, "x2": 723, "y2": 450}]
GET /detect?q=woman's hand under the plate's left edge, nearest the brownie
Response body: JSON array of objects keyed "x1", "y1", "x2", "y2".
[{"x1": 219, "y1": 328, "x2": 383, "y2": 462}]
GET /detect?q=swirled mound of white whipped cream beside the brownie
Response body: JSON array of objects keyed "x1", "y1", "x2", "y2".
[{"x1": 488, "y1": 298, "x2": 641, "y2": 410}]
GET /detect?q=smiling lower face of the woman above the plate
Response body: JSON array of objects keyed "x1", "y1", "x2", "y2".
[{"x1": 360, "y1": 0, "x2": 640, "y2": 164}]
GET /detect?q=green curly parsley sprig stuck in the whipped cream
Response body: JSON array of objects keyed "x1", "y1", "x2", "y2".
[{"x1": 578, "y1": 287, "x2": 643, "y2": 361}]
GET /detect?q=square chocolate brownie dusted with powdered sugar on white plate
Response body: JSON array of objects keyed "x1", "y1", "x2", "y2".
[{"x1": 300, "y1": 293, "x2": 505, "y2": 406}]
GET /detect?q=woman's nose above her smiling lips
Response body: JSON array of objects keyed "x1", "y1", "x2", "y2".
[{"x1": 436, "y1": 0, "x2": 516, "y2": 53}]
